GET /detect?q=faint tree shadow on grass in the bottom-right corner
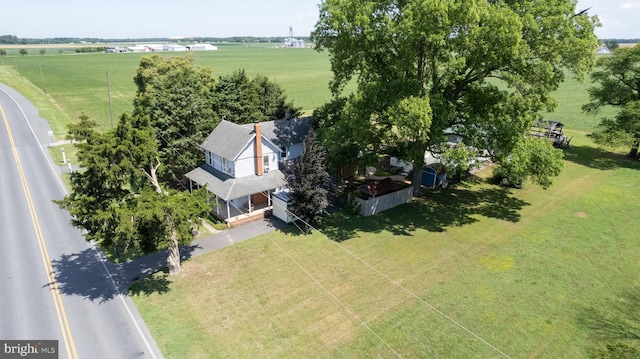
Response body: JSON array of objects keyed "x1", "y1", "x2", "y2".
[{"x1": 578, "y1": 288, "x2": 640, "y2": 344}]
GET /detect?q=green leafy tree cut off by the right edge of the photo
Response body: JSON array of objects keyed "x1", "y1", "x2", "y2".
[{"x1": 583, "y1": 45, "x2": 640, "y2": 157}]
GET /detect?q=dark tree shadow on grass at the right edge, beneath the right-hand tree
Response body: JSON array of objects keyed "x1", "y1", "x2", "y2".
[{"x1": 564, "y1": 146, "x2": 640, "y2": 171}]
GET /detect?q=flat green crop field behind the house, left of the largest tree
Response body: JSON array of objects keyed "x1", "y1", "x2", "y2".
[{"x1": 0, "y1": 44, "x2": 344, "y2": 135}]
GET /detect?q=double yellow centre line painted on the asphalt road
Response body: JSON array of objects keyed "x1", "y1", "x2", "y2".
[{"x1": 0, "y1": 106, "x2": 78, "y2": 359}]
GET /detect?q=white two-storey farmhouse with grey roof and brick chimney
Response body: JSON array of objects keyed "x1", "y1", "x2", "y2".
[{"x1": 186, "y1": 117, "x2": 311, "y2": 225}]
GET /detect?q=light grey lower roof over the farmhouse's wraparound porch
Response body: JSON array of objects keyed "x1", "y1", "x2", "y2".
[{"x1": 186, "y1": 164, "x2": 286, "y2": 201}]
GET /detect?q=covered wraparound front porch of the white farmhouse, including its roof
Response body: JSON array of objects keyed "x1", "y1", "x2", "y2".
[{"x1": 186, "y1": 164, "x2": 286, "y2": 226}]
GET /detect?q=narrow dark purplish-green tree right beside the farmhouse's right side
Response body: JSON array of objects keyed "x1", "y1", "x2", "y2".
[{"x1": 287, "y1": 129, "x2": 330, "y2": 231}]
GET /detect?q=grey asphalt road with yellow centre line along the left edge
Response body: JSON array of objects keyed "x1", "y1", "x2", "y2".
[{"x1": 0, "y1": 84, "x2": 162, "y2": 359}]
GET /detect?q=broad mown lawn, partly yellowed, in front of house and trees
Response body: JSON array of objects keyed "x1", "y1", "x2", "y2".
[{"x1": 133, "y1": 132, "x2": 640, "y2": 358}]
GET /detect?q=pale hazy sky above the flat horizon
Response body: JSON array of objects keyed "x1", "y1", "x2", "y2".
[{"x1": 0, "y1": 0, "x2": 640, "y2": 39}]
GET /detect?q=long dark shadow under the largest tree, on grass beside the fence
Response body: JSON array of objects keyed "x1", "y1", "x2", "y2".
[{"x1": 321, "y1": 179, "x2": 529, "y2": 242}]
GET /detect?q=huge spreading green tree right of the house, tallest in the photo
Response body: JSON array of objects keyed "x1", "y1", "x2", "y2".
[{"x1": 312, "y1": 0, "x2": 598, "y2": 192}]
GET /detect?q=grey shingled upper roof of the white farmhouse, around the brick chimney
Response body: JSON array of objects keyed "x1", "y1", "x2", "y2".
[{"x1": 200, "y1": 117, "x2": 311, "y2": 160}]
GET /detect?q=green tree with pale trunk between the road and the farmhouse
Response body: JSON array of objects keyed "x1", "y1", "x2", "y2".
[{"x1": 56, "y1": 115, "x2": 207, "y2": 274}]
